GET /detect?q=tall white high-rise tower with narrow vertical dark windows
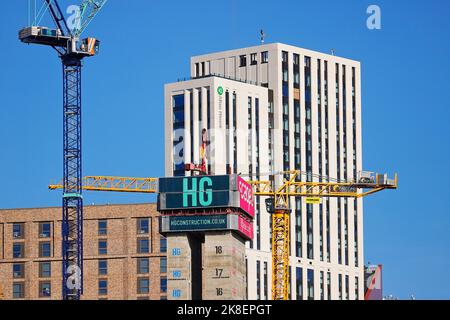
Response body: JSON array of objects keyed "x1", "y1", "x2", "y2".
[{"x1": 165, "y1": 43, "x2": 364, "y2": 300}]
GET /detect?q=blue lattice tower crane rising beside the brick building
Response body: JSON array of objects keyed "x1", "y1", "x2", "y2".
[{"x1": 19, "y1": 0, "x2": 107, "y2": 300}]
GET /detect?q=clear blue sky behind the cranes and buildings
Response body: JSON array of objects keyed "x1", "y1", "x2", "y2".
[{"x1": 0, "y1": 0, "x2": 450, "y2": 299}]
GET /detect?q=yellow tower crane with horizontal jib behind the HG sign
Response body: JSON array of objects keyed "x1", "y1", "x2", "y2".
[{"x1": 49, "y1": 170, "x2": 398, "y2": 300}]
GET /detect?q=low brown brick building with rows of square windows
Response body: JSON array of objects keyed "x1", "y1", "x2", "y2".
[{"x1": 0, "y1": 204, "x2": 167, "y2": 300}]
